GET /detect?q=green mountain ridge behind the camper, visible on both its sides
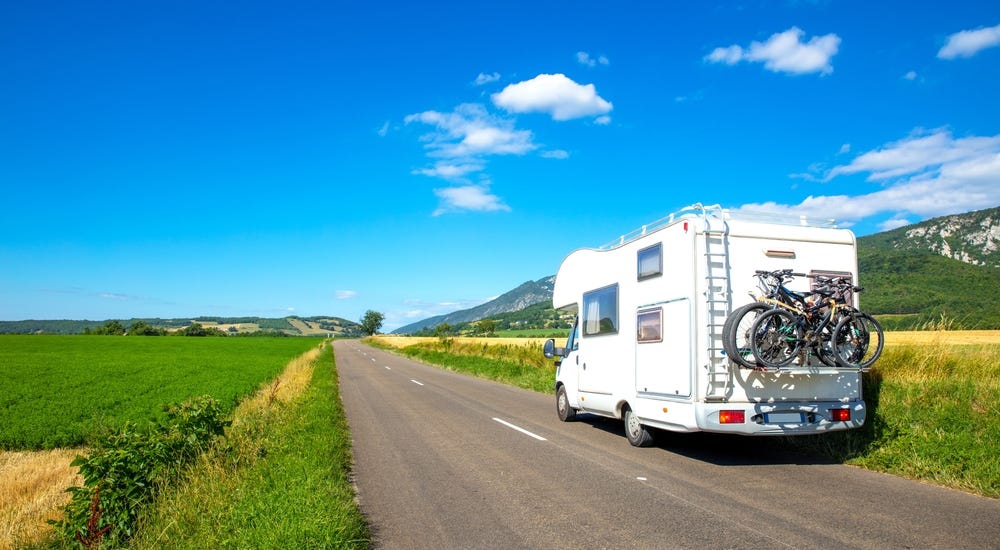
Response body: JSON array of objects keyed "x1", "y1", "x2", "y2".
[{"x1": 394, "y1": 207, "x2": 1000, "y2": 334}]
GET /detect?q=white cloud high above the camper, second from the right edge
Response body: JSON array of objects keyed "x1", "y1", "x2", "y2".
[{"x1": 705, "y1": 27, "x2": 840, "y2": 74}]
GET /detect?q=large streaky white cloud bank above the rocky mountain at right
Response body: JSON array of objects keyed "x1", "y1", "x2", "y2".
[{"x1": 741, "y1": 130, "x2": 1000, "y2": 227}]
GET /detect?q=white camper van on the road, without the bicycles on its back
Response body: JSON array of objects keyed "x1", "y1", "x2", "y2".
[{"x1": 545, "y1": 204, "x2": 865, "y2": 446}]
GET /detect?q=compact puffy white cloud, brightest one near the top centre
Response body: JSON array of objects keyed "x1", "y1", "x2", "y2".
[{"x1": 492, "y1": 74, "x2": 612, "y2": 120}]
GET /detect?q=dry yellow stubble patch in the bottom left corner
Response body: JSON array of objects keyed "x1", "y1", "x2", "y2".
[{"x1": 0, "y1": 449, "x2": 84, "y2": 550}]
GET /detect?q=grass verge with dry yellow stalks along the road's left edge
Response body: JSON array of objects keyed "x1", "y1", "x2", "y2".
[{"x1": 132, "y1": 345, "x2": 370, "y2": 548}]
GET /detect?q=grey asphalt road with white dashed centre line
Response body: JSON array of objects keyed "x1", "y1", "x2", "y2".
[{"x1": 334, "y1": 340, "x2": 1000, "y2": 549}]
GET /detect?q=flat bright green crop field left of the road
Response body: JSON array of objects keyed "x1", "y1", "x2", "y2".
[{"x1": 0, "y1": 335, "x2": 318, "y2": 450}]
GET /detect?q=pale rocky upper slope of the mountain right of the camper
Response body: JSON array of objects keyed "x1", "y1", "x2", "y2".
[{"x1": 859, "y1": 206, "x2": 1000, "y2": 268}]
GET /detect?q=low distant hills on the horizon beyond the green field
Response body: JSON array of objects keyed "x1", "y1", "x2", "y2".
[{"x1": 0, "y1": 316, "x2": 361, "y2": 337}]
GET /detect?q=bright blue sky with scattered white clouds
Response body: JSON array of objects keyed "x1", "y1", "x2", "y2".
[{"x1": 0, "y1": 0, "x2": 1000, "y2": 330}]
